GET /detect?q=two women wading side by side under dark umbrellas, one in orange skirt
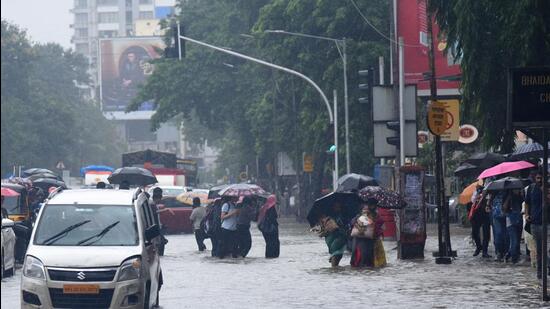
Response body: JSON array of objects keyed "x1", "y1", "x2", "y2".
[{"x1": 317, "y1": 198, "x2": 386, "y2": 267}]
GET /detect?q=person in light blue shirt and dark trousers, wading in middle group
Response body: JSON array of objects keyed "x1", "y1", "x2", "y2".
[{"x1": 218, "y1": 197, "x2": 239, "y2": 259}]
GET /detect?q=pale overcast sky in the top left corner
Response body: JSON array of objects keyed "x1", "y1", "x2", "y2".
[{"x1": 1, "y1": 0, "x2": 73, "y2": 48}]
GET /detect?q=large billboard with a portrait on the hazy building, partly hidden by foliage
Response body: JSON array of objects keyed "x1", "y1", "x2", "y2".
[{"x1": 99, "y1": 37, "x2": 164, "y2": 112}]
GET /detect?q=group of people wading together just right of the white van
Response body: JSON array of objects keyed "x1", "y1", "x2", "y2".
[{"x1": 190, "y1": 196, "x2": 280, "y2": 259}]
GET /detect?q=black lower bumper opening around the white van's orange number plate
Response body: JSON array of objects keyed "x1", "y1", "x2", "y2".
[{"x1": 50, "y1": 288, "x2": 114, "y2": 309}]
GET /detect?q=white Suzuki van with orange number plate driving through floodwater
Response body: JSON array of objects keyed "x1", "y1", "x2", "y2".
[{"x1": 21, "y1": 189, "x2": 162, "y2": 308}]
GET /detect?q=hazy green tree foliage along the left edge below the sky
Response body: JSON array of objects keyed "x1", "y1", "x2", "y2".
[{"x1": 1, "y1": 20, "x2": 121, "y2": 173}]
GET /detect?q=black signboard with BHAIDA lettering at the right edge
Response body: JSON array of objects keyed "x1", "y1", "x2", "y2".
[{"x1": 508, "y1": 67, "x2": 550, "y2": 128}]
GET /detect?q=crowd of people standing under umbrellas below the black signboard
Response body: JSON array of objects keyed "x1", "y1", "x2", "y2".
[{"x1": 468, "y1": 171, "x2": 543, "y2": 279}]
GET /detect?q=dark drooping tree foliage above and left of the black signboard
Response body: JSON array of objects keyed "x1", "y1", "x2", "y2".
[{"x1": 429, "y1": 0, "x2": 550, "y2": 152}]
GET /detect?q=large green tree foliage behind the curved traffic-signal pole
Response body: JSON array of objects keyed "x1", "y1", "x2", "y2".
[{"x1": 129, "y1": 0, "x2": 389, "y2": 192}]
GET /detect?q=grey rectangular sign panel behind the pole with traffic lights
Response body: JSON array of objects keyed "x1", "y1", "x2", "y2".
[{"x1": 372, "y1": 85, "x2": 418, "y2": 158}]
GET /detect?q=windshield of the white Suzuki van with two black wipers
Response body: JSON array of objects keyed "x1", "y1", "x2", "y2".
[{"x1": 34, "y1": 204, "x2": 139, "y2": 246}]
